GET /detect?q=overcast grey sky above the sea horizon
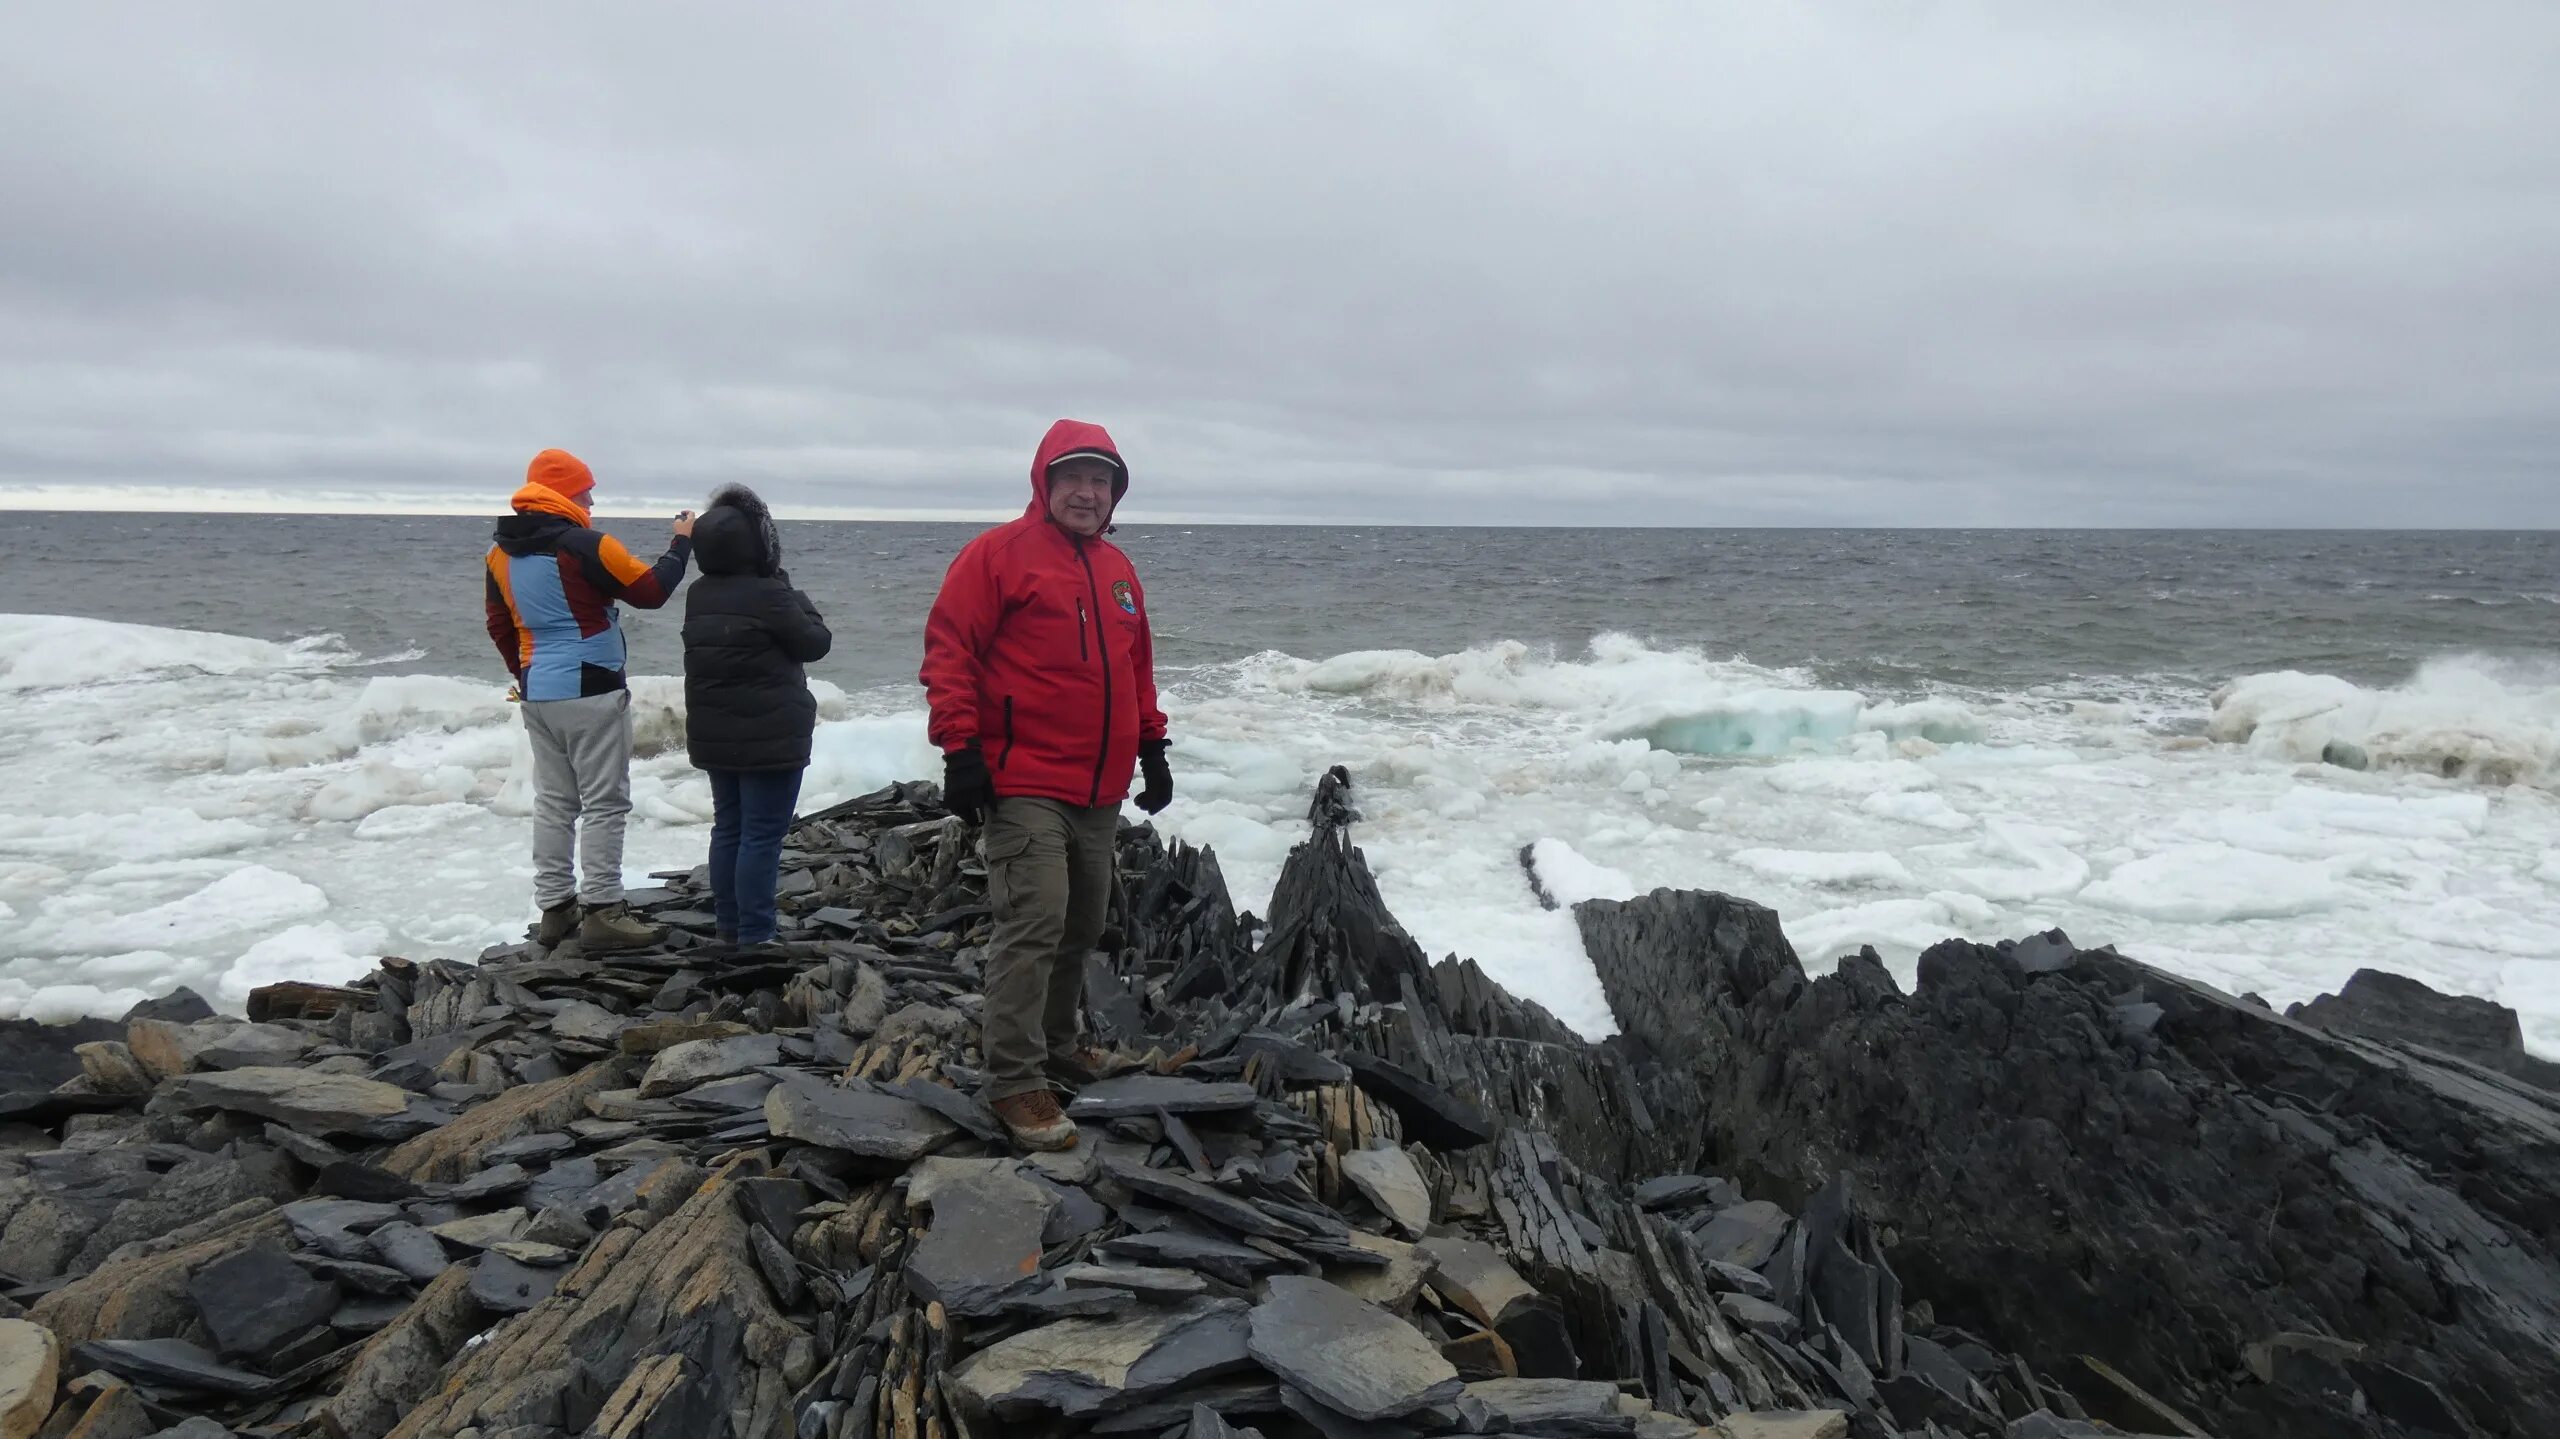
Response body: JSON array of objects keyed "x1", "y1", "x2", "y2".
[{"x1": 0, "y1": 0, "x2": 2560, "y2": 527}]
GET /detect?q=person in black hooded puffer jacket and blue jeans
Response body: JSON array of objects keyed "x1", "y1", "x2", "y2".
[{"x1": 684, "y1": 484, "x2": 832, "y2": 945}]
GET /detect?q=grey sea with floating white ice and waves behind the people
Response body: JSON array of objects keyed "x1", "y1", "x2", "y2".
[{"x1": 0, "y1": 515, "x2": 2560, "y2": 1055}]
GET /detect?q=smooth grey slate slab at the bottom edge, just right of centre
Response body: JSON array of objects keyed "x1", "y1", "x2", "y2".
[{"x1": 1252, "y1": 1275, "x2": 1467, "y2": 1421}]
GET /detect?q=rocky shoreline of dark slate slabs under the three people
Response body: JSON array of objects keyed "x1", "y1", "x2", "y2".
[{"x1": 0, "y1": 771, "x2": 2560, "y2": 1439}]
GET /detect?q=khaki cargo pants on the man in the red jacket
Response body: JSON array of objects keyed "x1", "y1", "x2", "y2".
[{"x1": 978, "y1": 796, "x2": 1119, "y2": 1101}]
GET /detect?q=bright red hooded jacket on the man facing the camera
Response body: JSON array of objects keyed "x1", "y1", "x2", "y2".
[{"x1": 919, "y1": 420, "x2": 1165, "y2": 807}]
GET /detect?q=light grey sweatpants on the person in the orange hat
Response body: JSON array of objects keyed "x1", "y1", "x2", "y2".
[{"x1": 525, "y1": 689, "x2": 632, "y2": 909}]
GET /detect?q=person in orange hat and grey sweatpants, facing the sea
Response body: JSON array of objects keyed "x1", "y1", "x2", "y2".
[{"x1": 484, "y1": 451, "x2": 694, "y2": 950}]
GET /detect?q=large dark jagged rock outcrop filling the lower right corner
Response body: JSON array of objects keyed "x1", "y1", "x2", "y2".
[{"x1": 1577, "y1": 891, "x2": 2560, "y2": 1439}]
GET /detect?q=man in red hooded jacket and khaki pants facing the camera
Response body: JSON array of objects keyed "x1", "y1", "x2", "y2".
[{"x1": 922, "y1": 420, "x2": 1172, "y2": 1150}]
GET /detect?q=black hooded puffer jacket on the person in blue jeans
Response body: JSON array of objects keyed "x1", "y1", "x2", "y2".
[{"x1": 684, "y1": 484, "x2": 835, "y2": 771}]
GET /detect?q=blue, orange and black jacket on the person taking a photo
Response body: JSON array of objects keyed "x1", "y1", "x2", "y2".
[{"x1": 486, "y1": 461, "x2": 694, "y2": 699}]
